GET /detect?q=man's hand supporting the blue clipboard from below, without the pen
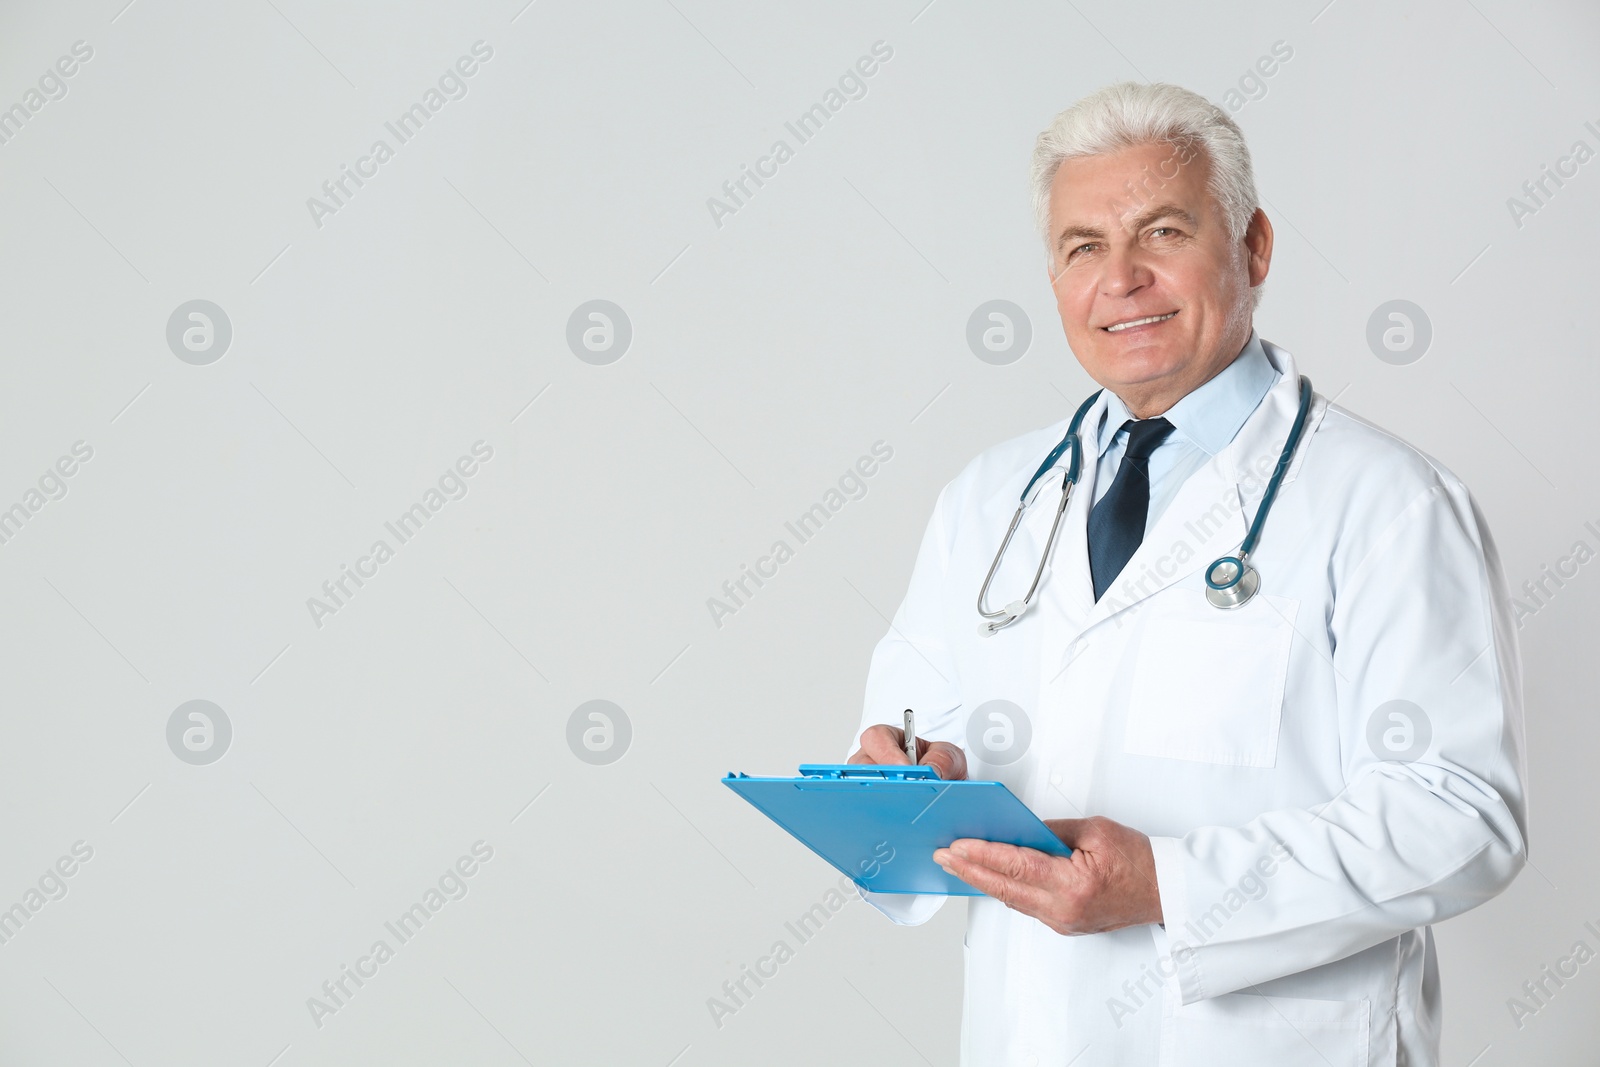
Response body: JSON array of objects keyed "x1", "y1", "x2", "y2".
[{"x1": 928, "y1": 819, "x2": 1162, "y2": 934}]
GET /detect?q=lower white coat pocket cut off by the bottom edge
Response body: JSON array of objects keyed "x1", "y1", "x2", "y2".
[{"x1": 1162, "y1": 989, "x2": 1371, "y2": 1067}]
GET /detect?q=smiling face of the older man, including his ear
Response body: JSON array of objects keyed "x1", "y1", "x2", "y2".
[{"x1": 1050, "y1": 144, "x2": 1272, "y2": 419}]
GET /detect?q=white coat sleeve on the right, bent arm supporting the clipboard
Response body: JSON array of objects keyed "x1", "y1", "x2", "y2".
[{"x1": 1152, "y1": 482, "x2": 1526, "y2": 1005}]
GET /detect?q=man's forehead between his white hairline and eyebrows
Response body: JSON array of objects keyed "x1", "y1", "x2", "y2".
[{"x1": 1050, "y1": 142, "x2": 1211, "y2": 232}]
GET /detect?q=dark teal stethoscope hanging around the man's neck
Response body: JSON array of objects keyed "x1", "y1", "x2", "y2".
[{"x1": 978, "y1": 374, "x2": 1310, "y2": 637}]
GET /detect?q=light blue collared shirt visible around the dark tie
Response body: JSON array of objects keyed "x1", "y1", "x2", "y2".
[{"x1": 1094, "y1": 330, "x2": 1278, "y2": 531}]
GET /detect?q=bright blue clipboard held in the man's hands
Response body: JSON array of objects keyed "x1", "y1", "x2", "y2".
[{"x1": 722, "y1": 763, "x2": 1072, "y2": 896}]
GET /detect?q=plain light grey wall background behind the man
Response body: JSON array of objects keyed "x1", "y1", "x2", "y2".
[{"x1": 0, "y1": 0, "x2": 1600, "y2": 1067}]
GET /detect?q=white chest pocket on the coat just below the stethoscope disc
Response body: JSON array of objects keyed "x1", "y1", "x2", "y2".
[{"x1": 1123, "y1": 589, "x2": 1299, "y2": 766}]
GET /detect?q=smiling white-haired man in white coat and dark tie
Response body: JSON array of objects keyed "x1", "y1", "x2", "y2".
[{"x1": 850, "y1": 83, "x2": 1526, "y2": 1067}]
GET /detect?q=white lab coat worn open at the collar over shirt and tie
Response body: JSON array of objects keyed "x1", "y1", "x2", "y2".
[{"x1": 850, "y1": 342, "x2": 1526, "y2": 1067}]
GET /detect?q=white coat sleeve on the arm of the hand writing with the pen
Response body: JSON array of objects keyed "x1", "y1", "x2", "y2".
[{"x1": 845, "y1": 486, "x2": 976, "y2": 926}]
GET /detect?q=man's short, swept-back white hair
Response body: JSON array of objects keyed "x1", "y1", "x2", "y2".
[{"x1": 1029, "y1": 82, "x2": 1261, "y2": 301}]
